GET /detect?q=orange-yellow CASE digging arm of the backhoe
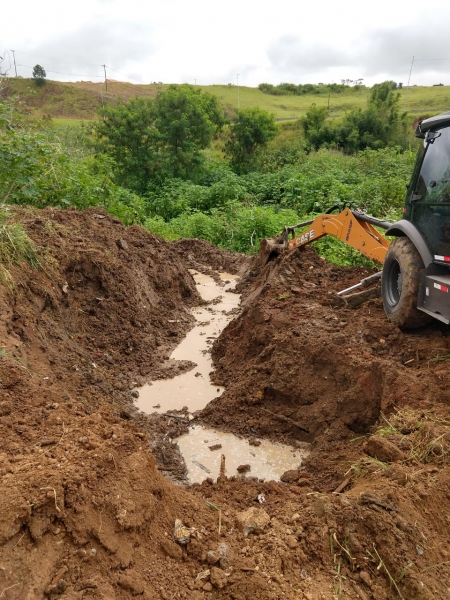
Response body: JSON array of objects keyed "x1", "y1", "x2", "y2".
[{"x1": 259, "y1": 208, "x2": 390, "y2": 265}]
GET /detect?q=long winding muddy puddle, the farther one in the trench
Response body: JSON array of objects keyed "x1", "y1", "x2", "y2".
[{"x1": 136, "y1": 270, "x2": 240, "y2": 413}]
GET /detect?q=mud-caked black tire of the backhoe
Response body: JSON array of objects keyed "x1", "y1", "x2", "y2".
[{"x1": 381, "y1": 237, "x2": 432, "y2": 329}]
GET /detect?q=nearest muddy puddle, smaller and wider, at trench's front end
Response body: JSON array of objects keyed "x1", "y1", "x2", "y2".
[{"x1": 177, "y1": 425, "x2": 308, "y2": 483}]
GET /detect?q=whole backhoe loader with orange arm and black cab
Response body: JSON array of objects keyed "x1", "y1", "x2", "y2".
[{"x1": 260, "y1": 112, "x2": 450, "y2": 329}]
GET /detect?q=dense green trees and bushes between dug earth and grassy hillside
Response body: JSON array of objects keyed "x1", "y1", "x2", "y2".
[{"x1": 0, "y1": 82, "x2": 428, "y2": 265}]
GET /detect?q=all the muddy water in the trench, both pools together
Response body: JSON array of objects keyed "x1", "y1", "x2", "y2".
[{"x1": 137, "y1": 270, "x2": 307, "y2": 483}]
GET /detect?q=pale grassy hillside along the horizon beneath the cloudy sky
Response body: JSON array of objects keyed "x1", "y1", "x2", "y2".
[{"x1": 0, "y1": 78, "x2": 450, "y2": 120}]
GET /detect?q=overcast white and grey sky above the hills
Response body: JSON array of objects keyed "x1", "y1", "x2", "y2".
[{"x1": 0, "y1": 0, "x2": 450, "y2": 87}]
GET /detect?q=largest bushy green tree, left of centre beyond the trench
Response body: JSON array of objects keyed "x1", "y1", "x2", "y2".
[{"x1": 95, "y1": 85, "x2": 223, "y2": 194}]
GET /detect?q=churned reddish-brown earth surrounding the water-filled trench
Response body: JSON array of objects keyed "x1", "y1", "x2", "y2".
[{"x1": 0, "y1": 209, "x2": 450, "y2": 600}]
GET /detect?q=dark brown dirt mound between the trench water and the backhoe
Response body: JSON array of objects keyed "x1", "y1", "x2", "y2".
[{"x1": 202, "y1": 248, "x2": 450, "y2": 450}]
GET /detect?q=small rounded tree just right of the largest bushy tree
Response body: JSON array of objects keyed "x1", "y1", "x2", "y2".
[{"x1": 224, "y1": 107, "x2": 278, "y2": 175}]
